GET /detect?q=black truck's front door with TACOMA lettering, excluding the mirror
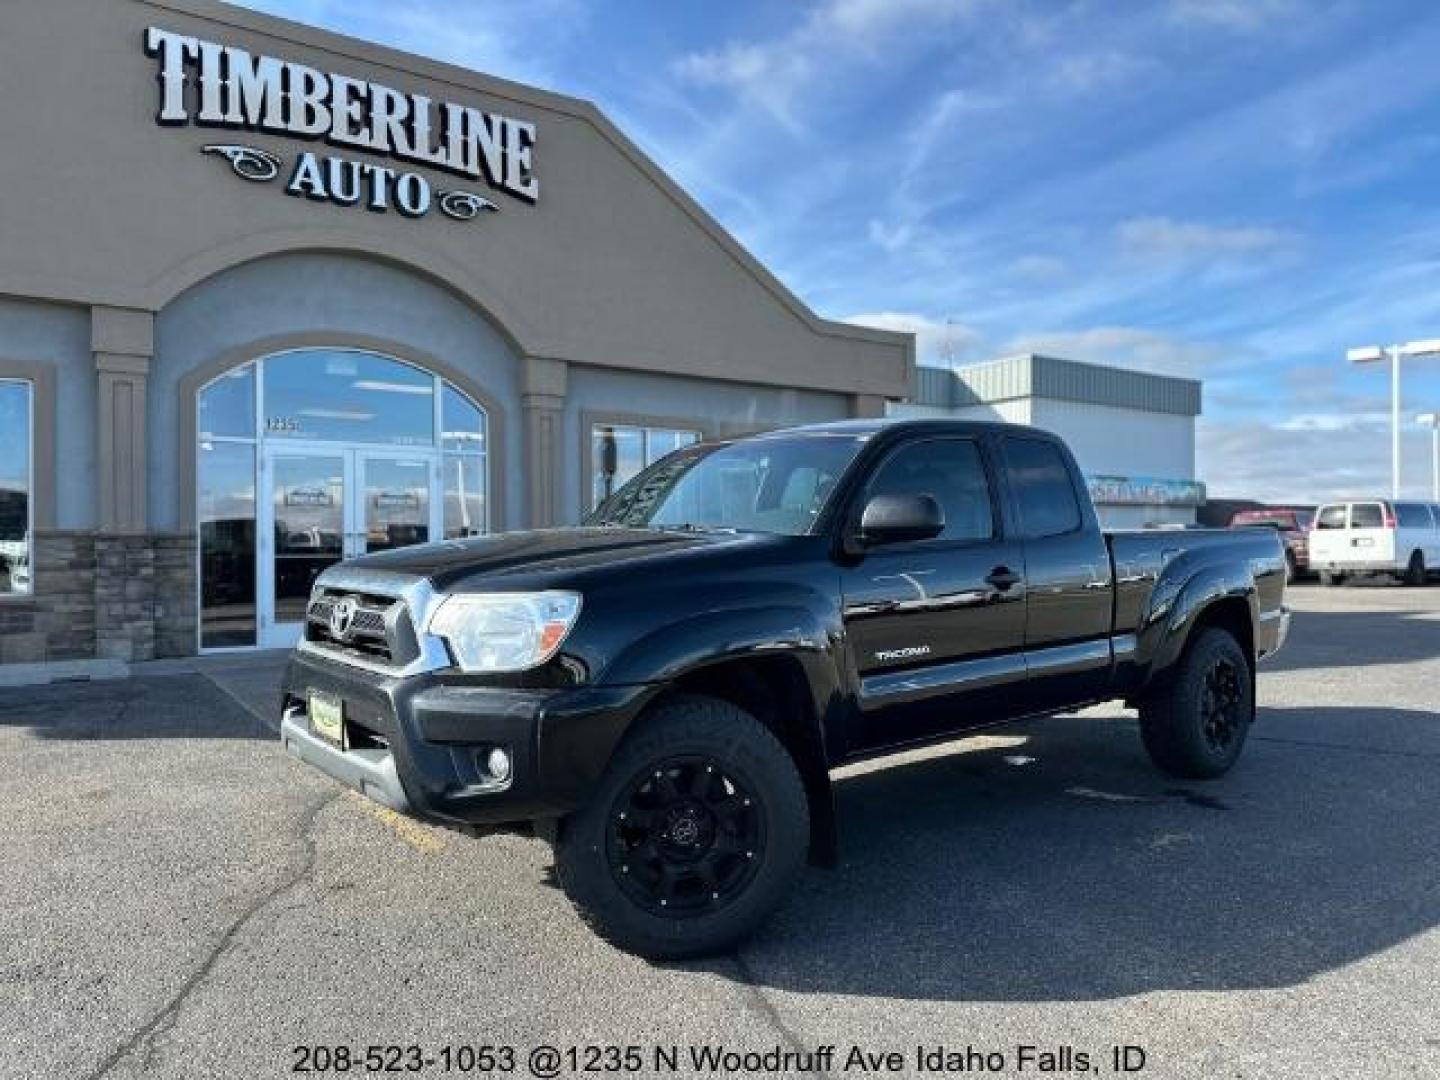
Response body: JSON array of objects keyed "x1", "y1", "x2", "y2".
[{"x1": 841, "y1": 436, "x2": 1025, "y2": 747}]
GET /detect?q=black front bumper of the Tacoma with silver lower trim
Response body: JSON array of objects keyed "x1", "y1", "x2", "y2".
[{"x1": 281, "y1": 652, "x2": 654, "y2": 825}]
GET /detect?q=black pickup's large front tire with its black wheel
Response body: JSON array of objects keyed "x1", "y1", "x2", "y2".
[{"x1": 554, "y1": 697, "x2": 809, "y2": 959}]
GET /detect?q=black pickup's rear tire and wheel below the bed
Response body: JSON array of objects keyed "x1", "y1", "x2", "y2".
[{"x1": 1140, "y1": 626, "x2": 1254, "y2": 780}]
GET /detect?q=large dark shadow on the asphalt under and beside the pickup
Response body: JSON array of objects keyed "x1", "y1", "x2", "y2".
[{"x1": 710, "y1": 708, "x2": 1440, "y2": 1001}]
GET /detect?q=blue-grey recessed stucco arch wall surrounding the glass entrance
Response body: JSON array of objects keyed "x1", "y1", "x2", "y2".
[{"x1": 147, "y1": 246, "x2": 523, "y2": 530}]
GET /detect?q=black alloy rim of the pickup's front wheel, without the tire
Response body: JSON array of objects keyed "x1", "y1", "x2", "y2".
[{"x1": 605, "y1": 756, "x2": 766, "y2": 919}]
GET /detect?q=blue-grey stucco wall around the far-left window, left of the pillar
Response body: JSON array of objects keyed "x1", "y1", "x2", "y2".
[{"x1": 0, "y1": 297, "x2": 95, "y2": 528}]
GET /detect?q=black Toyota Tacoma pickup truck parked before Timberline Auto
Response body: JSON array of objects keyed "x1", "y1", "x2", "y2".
[{"x1": 281, "y1": 420, "x2": 1289, "y2": 958}]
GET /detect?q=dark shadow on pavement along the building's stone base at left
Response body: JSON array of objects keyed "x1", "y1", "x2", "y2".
[{"x1": 0, "y1": 674, "x2": 275, "y2": 740}]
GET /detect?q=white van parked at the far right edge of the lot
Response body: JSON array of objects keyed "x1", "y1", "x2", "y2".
[{"x1": 1310, "y1": 498, "x2": 1440, "y2": 585}]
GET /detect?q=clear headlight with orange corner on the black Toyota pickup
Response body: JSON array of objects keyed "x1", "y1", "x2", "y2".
[{"x1": 429, "y1": 592, "x2": 580, "y2": 671}]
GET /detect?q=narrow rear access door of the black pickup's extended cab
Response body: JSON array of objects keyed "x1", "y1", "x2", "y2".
[{"x1": 1001, "y1": 435, "x2": 1115, "y2": 710}]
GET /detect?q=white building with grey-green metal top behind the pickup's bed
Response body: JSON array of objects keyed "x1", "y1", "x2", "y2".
[{"x1": 890, "y1": 353, "x2": 1205, "y2": 528}]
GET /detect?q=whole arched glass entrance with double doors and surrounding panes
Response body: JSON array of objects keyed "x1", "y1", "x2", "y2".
[{"x1": 196, "y1": 348, "x2": 490, "y2": 649}]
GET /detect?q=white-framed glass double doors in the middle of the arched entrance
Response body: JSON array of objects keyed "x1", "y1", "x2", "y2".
[{"x1": 256, "y1": 445, "x2": 439, "y2": 648}]
